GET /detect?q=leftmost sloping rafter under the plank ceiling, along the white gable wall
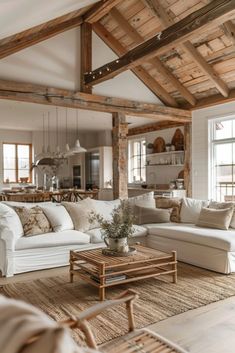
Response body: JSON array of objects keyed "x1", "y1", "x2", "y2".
[{"x1": 92, "y1": 22, "x2": 178, "y2": 107}]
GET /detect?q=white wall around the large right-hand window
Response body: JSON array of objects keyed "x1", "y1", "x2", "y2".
[{"x1": 192, "y1": 102, "x2": 235, "y2": 199}]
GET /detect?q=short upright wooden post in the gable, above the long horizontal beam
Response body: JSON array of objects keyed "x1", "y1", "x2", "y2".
[{"x1": 81, "y1": 22, "x2": 92, "y2": 93}]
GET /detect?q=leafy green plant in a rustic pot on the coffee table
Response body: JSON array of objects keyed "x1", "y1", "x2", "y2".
[{"x1": 89, "y1": 200, "x2": 135, "y2": 252}]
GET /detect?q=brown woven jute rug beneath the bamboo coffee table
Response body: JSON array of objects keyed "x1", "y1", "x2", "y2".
[{"x1": 2, "y1": 263, "x2": 235, "y2": 344}]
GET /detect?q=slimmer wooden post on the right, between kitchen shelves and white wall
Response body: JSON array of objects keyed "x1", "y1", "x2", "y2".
[{"x1": 184, "y1": 123, "x2": 192, "y2": 197}]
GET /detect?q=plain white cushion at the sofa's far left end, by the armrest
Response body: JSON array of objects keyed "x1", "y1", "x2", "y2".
[{"x1": 0, "y1": 202, "x2": 24, "y2": 239}]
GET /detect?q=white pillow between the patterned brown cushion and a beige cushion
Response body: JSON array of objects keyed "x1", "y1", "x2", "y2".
[{"x1": 41, "y1": 205, "x2": 74, "y2": 232}]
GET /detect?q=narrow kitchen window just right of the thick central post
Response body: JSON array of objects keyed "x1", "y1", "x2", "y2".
[{"x1": 128, "y1": 138, "x2": 146, "y2": 183}]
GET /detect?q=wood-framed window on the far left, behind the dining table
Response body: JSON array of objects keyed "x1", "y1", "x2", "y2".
[{"x1": 3, "y1": 143, "x2": 32, "y2": 183}]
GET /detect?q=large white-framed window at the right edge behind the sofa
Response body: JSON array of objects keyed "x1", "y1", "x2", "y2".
[{"x1": 210, "y1": 117, "x2": 235, "y2": 201}]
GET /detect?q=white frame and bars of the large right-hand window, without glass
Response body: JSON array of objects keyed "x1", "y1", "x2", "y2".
[{"x1": 208, "y1": 114, "x2": 235, "y2": 202}]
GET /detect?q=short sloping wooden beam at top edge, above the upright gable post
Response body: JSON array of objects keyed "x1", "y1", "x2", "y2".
[{"x1": 83, "y1": 0, "x2": 123, "y2": 23}]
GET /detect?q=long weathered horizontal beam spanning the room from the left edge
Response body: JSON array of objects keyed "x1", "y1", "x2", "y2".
[{"x1": 0, "y1": 80, "x2": 191, "y2": 122}]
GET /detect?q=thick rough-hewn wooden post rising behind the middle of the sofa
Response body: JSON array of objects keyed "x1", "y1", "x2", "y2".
[{"x1": 113, "y1": 113, "x2": 128, "y2": 199}]
